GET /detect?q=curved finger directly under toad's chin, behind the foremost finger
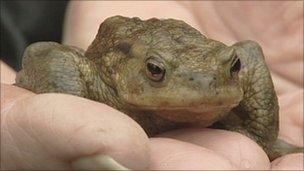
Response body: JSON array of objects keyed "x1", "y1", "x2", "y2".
[{"x1": 160, "y1": 129, "x2": 270, "y2": 170}]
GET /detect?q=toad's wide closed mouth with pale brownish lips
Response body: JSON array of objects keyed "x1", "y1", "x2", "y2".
[{"x1": 121, "y1": 89, "x2": 242, "y2": 113}]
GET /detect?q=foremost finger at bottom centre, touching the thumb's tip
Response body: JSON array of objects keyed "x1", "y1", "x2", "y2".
[{"x1": 149, "y1": 138, "x2": 235, "y2": 170}]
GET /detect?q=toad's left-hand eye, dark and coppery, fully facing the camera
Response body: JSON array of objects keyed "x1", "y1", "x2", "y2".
[{"x1": 146, "y1": 58, "x2": 166, "y2": 82}]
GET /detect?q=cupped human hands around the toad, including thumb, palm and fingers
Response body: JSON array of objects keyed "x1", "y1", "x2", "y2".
[{"x1": 1, "y1": 1, "x2": 303, "y2": 170}]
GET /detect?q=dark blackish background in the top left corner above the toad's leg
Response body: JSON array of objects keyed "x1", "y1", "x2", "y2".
[{"x1": 0, "y1": 0, "x2": 68, "y2": 71}]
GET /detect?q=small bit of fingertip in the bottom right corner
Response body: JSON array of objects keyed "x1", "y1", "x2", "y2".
[{"x1": 271, "y1": 153, "x2": 304, "y2": 170}]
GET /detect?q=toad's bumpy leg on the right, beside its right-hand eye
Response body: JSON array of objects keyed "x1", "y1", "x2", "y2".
[{"x1": 221, "y1": 41, "x2": 303, "y2": 160}]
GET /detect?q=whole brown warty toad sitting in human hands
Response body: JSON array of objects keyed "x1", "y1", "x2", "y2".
[{"x1": 16, "y1": 16, "x2": 303, "y2": 159}]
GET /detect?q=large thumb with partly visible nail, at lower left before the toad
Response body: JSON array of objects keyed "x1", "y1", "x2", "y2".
[{"x1": 1, "y1": 90, "x2": 149, "y2": 170}]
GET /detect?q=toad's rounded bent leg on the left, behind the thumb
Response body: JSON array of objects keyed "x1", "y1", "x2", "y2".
[{"x1": 15, "y1": 42, "x2": 105, "y2": 101}]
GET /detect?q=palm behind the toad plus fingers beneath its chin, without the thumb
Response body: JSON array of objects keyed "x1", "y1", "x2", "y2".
[{"x1": 64, "y1": 1, "x2": 303, "y2": 170}]
